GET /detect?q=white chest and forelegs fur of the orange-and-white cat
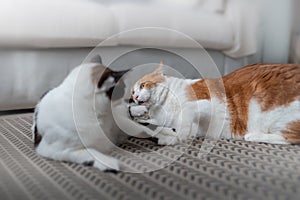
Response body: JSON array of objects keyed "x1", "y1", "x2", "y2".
[{"x1": 131, "y1": 77, "x2": 231, "y2": 144}]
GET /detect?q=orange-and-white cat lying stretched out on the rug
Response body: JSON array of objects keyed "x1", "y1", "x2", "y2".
[{"x1": 130, "y1": 64, "x2": 300, "y2": 144}]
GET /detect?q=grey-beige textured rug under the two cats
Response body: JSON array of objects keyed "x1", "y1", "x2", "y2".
[{"x1": 0, "y1": 114, "x2": 300, "y2": 200}]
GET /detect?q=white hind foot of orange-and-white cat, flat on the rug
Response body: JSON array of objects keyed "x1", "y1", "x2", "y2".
[{"x1": 244, "y1": 133, "x2": 290, "y2": 144}]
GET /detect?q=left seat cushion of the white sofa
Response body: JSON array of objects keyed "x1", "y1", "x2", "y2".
[{"x1": 0, "y1": 0, "x2": 117, "y2": 48}]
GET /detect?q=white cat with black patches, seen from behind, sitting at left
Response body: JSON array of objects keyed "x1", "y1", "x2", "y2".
[{"x1": 32, "y1": 60, "x2": 155, "y2": 170}]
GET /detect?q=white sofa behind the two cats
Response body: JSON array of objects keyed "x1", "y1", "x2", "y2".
[{"x1": 0, "y1": 0, "x2": 292, "y2": 110}]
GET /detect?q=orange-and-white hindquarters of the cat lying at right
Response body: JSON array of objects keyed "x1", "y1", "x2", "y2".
[{"x1": 223, "y1": 64, "x2": 300, "y2": 143}]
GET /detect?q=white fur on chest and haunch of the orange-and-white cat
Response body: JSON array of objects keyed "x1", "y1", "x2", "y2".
[{"x1": 130, "y1": 77, "x2": 300, "y2": 144}]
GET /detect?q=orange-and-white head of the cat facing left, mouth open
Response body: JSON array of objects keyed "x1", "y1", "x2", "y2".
[{"x1": 131, "y1": 62, "x2": 165, "y2": 106}]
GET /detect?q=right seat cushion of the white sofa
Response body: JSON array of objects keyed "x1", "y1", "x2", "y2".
[{"x1": 111, "y1": 4, "x2": 234, "y2": 50}]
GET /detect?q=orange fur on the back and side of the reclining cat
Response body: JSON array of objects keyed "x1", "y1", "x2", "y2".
[{"x1": 188, "y1": 64, "x2": 300, "y2": 136}]
